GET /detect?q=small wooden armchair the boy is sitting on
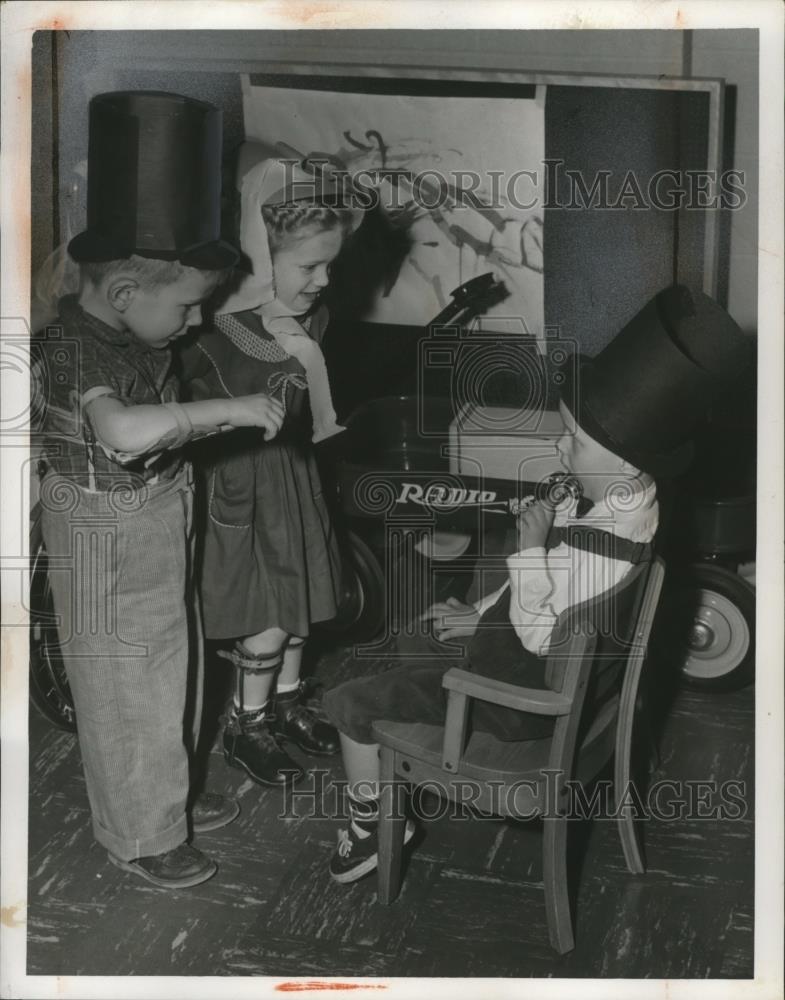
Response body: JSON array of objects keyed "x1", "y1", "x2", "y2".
[{"x1": 373, "y1": 558, "x2": 664, "y2": 954}]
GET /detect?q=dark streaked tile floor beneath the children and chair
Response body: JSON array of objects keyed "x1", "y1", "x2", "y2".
[{"x1": 27, "y1": 650, "x2": 754, "y2": 978}]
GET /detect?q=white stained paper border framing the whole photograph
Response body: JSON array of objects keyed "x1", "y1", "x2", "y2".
[{"x1": 0, "y1": 0, "x2": 783, "y2": 1000}]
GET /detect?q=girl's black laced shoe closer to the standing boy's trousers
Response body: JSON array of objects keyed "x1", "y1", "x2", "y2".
[{"x1": 223, "y1": 708, "x2": 305, "y2": 788}]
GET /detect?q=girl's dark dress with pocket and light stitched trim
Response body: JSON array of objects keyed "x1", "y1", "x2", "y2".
[{"x1": 182, "y1": 312, "x2": 340, "y2": 639}]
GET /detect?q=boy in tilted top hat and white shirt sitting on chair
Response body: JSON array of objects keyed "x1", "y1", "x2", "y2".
[{"x1": 323, "y1": 286, "x2": 751, "y2": 883}]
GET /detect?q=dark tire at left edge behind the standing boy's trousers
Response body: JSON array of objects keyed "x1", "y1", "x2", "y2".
[{"x1": 29, "y1": 505, "x2": 76, "y2": 733}]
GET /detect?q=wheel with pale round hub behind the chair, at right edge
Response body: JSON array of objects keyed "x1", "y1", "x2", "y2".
[{"x1": 664, "y1": 562, "x2": 755, "y2": 691}]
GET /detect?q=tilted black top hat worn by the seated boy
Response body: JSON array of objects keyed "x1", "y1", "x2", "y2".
[{"x1": 562, "y1": 285, "x2": 754, "y2": 476}]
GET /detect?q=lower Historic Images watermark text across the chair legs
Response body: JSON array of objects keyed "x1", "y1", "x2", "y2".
[{"x1": 278, "y1": 768, "x2": 749, "y2": 823}]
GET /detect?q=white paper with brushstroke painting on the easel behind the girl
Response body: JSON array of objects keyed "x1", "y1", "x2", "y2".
[{"x1": 243, "y1": 76, "x2": 546, "y2": 341}]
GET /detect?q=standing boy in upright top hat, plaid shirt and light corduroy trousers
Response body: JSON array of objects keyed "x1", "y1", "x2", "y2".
[{"x1": 38, "y1": 93, "x2": 283, "y2": 887}]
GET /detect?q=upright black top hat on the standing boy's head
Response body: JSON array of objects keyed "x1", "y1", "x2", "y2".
[{"x1": 68, "y1": 91, "x2": 239, "y2": 270}]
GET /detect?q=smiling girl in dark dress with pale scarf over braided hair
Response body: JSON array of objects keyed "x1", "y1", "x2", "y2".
[{"x1": 183, "y1": 160, "x2": 362, "y2": 786}]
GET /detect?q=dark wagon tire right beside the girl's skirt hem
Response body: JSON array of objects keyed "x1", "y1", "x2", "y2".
[{"x1": 318, "y1": 530, "x2": 386, "y2": 643}]
